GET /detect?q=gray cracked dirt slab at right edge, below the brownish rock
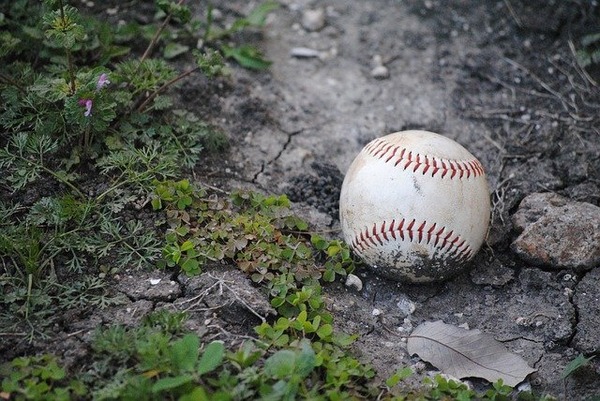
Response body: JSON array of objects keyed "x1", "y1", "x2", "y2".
[{"x1": 573, "y1": 269, "x2": 600, "y2": 354}]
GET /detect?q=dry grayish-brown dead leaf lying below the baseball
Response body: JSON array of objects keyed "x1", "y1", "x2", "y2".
[{"x1": 407, "y1": 320, "x2": 535, "y2": 387}]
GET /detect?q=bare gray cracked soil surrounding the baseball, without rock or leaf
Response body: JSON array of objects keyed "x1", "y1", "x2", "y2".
[{"x1": 193, "y1": 0, "x2": 600, "y2": 394}]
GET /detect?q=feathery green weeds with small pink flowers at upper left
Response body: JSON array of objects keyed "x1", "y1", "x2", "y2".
[{"x1": 0, "y1": 0, "x2": 275, "y2": 339}]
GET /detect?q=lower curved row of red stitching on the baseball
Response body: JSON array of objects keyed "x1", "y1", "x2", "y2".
[{"x1": 351, "y1": 219, "x2": 473, "y2": 260}]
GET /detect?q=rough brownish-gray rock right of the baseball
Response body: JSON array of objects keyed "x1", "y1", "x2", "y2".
[{"x1": 511, "y1": 193, "x2": 600, "y2": 270}]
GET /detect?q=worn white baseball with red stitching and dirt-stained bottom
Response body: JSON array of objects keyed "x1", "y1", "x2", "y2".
[{"x1": 340, "y1": 131, "x2": 490, "y2": 282}]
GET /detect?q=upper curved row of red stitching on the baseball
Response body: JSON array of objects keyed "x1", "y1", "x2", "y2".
[{"x1": 365, "y1": 138, "x2": 485, "y2": 179}]
